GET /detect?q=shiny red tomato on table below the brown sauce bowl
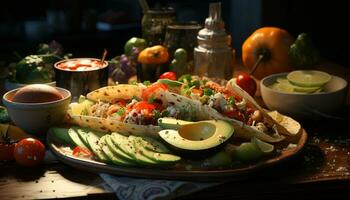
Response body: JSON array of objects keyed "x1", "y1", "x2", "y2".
[{"x1": 14, "y1": 138, "x2": 45, "y2": 166}]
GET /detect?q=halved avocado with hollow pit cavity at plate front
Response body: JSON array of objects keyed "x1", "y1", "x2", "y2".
[{"x1": 159, "y1": 120, "x2": 234, "y2": 152}]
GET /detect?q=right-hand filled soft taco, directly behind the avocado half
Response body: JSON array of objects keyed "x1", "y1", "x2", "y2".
[{"x1": 158, "y1": 76, "x2": 301, "y2": 143}]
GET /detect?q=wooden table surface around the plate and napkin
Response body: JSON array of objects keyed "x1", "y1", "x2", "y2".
[{"x1": 0, "y1": 60, "x2": 350, "y2": 200}]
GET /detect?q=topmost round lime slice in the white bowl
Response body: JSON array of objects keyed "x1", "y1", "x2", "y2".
[{"x1": 287, "y1": 70, "x2": 332, "y2": 87}]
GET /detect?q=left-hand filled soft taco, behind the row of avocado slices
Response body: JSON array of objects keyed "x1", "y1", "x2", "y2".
[{"x1": 67, "y1": 83, "x2": 203, "y2": 137}]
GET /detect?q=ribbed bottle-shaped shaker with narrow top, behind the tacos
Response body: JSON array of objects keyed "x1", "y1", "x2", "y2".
[{"x1": 193, "y1": 3, "x2": 233, "y2": 79}]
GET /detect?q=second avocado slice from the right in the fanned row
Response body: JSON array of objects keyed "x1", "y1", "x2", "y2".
[{"x1": 112, "y1": 133, "x2": 157, "y2": 165}]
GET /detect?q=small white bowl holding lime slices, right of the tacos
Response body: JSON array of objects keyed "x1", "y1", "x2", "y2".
[{"x1": 260, "y1": 70, "x2": 348, "y2": 119}]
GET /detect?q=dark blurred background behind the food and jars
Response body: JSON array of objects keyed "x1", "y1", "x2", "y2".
[{"x1": 0, "y1": 0, "x2": 350, "y2": 67}]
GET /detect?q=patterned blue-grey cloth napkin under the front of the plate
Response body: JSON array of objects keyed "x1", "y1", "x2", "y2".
[{"x1": 100, "y1": 173, "x2": 220, "y2": 200}]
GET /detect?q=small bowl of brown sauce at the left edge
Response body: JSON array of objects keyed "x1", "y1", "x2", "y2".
[{"x1": 2, "y1": 84, "x2": 71, "y2": 139}]
